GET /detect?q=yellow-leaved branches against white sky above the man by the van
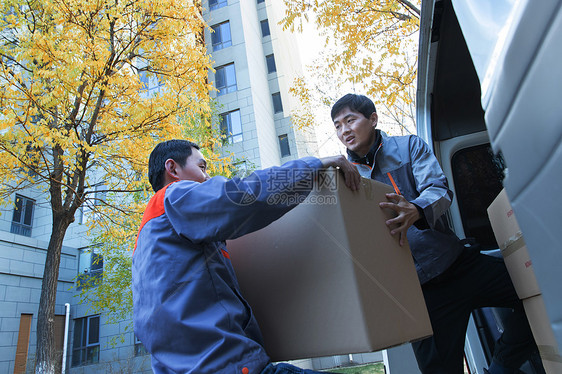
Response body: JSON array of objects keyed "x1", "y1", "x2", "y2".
[{"x1": 282, "y1": 0, "x2": 420, "y2": 134}]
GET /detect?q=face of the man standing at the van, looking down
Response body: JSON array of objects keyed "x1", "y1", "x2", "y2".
[{"x1": 334, "y1": 108, "x2": 378, "y2": 156}]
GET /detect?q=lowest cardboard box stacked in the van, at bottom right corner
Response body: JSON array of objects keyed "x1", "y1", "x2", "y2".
[{"x1": 523, "y1": 295, "x2": 562, "y2": 374}]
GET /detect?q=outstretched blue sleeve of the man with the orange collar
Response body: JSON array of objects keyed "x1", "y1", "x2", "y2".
[{"x1": 164, "y1": 157, "x2": 322, "y2": 243}]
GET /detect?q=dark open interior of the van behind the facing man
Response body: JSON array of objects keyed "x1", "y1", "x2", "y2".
[{"x1": 417, "y1": 0, "x2": 544, "y2": 373}]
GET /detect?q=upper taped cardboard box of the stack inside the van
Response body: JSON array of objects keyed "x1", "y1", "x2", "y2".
[{"x1": 488, "y1": 190, "x2": 541, "y2": 299}]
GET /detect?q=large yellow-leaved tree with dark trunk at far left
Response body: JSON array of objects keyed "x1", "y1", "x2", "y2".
[{"x1": 0, "y1": 0, "x2": 223, "y2": 373}]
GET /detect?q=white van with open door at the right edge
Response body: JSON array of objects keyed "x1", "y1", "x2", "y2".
[{"x1": 417, "y1": 0, "x2": 562, "y2": 373}]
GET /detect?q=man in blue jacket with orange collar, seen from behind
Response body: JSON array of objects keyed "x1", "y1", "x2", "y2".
[{"x1": 133, "y1": 140, "x2": 360, "y2": 374}]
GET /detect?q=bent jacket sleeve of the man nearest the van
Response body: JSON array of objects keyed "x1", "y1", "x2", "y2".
[{"x1": 404, "y1": 136, "x2": 453, "y2": 229}]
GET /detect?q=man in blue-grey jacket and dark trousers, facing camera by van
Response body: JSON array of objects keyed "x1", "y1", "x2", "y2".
[{"x1": 331, "y1": 94, "x2": 536, "y2": 374}]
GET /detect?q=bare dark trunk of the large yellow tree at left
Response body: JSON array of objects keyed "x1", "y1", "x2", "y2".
[{"x1": 35, "y1": 212, "x2": 72, "y2": 374}]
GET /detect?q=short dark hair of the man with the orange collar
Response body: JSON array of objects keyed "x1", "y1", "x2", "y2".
[{"x1": 148, "y1": 139, "x2": 199, "y2": 192}]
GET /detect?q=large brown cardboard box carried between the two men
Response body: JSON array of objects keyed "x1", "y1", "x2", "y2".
[{"x1": 227, "y1": 170, "x2": 432, "y2": 361}]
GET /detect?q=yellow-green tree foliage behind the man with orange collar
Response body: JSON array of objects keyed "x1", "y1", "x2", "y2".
[{"x1": 76, "y1": 108, "x2": 236, "y2": 345}]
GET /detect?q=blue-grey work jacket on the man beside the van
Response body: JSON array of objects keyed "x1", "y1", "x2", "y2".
[{"x1": 348, "y1": 130, "x2": 464, "y2": 284}]
